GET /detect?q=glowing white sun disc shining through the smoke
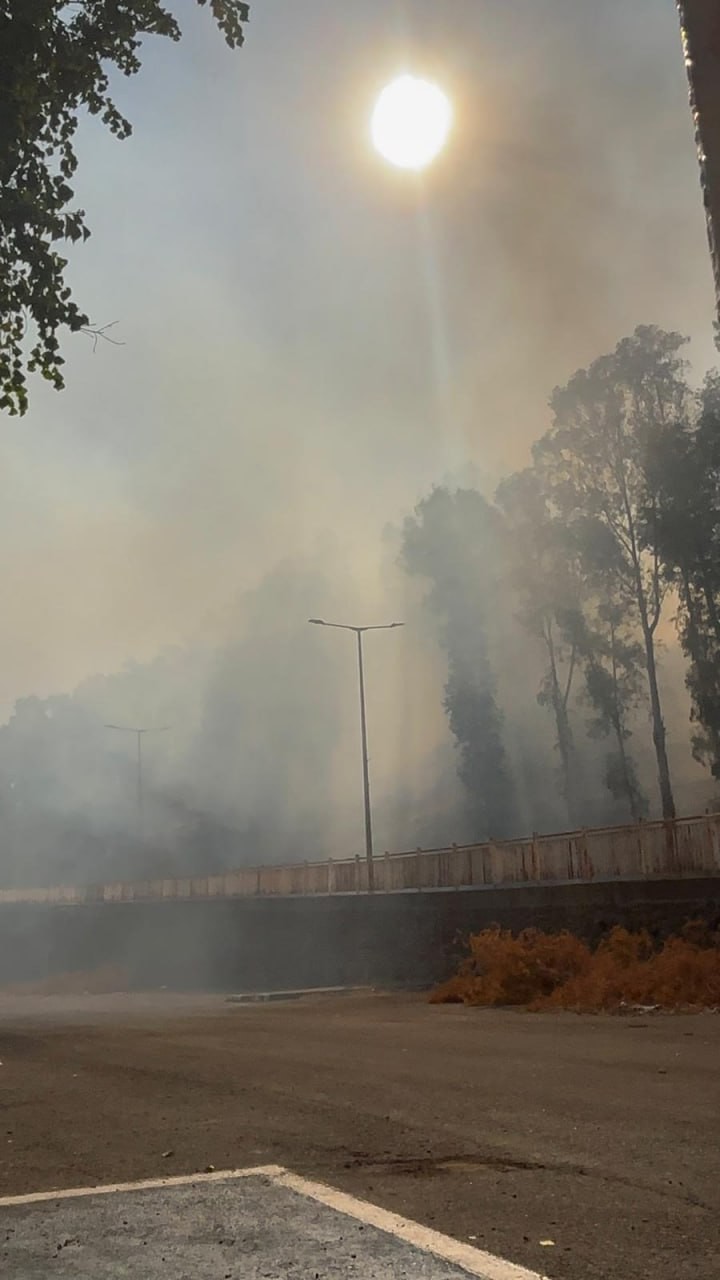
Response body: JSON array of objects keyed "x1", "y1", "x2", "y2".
[{"x1": 370, "y1": 76, "x2": 452, "y2": 169}]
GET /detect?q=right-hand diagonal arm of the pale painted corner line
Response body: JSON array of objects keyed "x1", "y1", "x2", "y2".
[{"x1": 270, "y1": 1171, "x2": 547, "y2": 1280}]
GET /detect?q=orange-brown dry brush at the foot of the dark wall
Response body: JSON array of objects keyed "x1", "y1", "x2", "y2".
[{"x1": 430, "y1": 922, "x2": 720, "y2": 1012}]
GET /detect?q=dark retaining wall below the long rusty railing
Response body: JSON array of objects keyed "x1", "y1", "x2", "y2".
[{"x1": 0, "y1": 878, "x2": 720, "y2": 992}]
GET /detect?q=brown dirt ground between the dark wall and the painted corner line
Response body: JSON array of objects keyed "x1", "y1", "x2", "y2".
[{"x1": 0, "y1": 996, "x2": 720, "y2": 1280}]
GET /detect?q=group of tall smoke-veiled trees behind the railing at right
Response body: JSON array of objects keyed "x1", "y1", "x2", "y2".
[{"x1": 401, "y1": 326, "x2": 720, "y2": 836}]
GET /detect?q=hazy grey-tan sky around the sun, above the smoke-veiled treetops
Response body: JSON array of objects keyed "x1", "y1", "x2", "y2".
[{"x1": 0, "y1": 0, "x2": 712, "y2": 707}]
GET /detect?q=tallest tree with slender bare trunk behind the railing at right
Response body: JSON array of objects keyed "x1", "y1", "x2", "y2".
[{"x1": 533, "y1": 325, "x2": 691, "y2": 818}]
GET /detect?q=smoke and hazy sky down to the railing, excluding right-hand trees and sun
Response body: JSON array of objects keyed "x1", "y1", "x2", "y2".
[{"x1": 0, "y1": 0, "x2": 712, "y2": 883}]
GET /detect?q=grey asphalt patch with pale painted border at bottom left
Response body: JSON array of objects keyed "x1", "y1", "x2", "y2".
[{"x1": 0, "y1": 1169, "x2": 515, "y2": 1280}]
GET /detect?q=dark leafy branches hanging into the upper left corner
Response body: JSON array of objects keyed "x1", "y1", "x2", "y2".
[{"x1": 0, "y1": 0, "x2": 250, "y2": 413}]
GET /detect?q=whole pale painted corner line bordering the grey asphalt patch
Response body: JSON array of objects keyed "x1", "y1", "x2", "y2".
[{"x1": 0, "y1": 1165, "x2": 546, "y2": 1280}]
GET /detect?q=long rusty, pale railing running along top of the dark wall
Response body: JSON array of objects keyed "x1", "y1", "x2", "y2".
[{"x1": 0, "y1": 814, "x2": 720, "y2": 905}]
